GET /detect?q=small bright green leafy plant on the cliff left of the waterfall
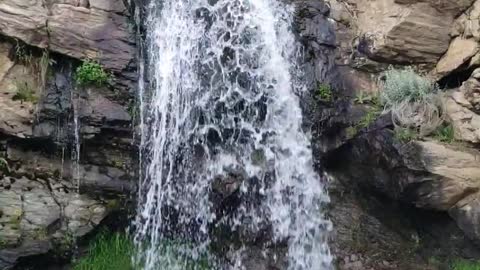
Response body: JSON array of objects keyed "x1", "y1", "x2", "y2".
[{"x1": 74, "y1": 60, "x2": 111, "y2": 86}]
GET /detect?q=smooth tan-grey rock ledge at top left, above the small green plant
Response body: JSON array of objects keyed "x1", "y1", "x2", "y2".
[{"x1": 0, "y1": 0, "x2": 135, "y2": 72}]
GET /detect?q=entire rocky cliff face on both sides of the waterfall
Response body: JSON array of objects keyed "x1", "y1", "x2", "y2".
[{"x1": 0, "y1": 0, "x2": 480, "y2": 269}]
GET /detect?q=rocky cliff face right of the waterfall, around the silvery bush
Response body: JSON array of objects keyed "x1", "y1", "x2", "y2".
[{"x1": 320, "y1": 0, "x2": 480, "y2": 269}]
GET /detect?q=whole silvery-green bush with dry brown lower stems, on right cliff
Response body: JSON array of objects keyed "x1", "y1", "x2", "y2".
[{"x1": 380, "y1": 68, "x2": 444, "y2": 136}]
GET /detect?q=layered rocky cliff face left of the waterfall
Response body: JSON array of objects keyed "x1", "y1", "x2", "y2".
[{"x1": 0, "y1": 0, "x2": 136, "y2": 269}]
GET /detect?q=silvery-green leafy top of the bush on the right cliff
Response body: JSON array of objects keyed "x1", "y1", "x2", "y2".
[{"x1": 380, "y1": 67, "x2": 438, "y2": 107}]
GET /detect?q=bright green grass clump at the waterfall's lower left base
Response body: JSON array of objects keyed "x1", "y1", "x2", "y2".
[{"x1": 72, "y1": 232, "x2": 134, "y2": 270}]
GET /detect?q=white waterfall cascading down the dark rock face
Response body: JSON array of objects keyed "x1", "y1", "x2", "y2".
[{"x1": 135, "y1": 0, "x2": 332, "y2": 270}]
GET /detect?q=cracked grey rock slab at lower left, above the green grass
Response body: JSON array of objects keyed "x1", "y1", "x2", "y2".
[{"x1": 0, "y1": 177, "x2": 108, "y2": 269}]
